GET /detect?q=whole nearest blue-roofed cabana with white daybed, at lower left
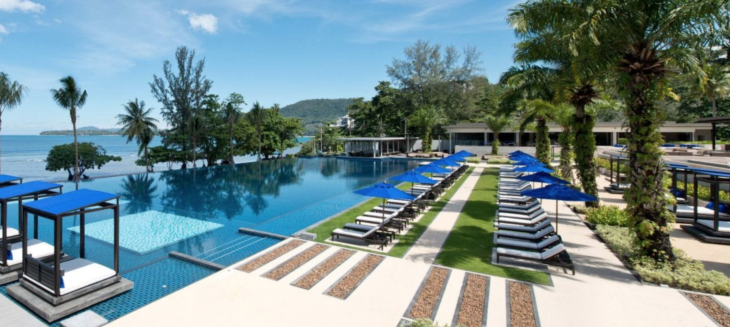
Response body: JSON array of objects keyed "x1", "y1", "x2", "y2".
[{"x1": 8, "y1": 189, "x2": 133, "y2": 322}]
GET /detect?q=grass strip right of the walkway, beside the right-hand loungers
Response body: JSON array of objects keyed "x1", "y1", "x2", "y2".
[{"x1": 435, "y1": 168, "x2": 550, "y2": 285}]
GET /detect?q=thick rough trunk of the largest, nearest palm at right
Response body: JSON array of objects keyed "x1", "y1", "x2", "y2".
[{"x1": 619, "y1": 42, "x2": 674, "y2": 260}]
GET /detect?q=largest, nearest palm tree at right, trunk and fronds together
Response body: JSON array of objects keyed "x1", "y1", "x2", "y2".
[{"x1": 510, "y1": 0, "x2": 730, "y2": 260}]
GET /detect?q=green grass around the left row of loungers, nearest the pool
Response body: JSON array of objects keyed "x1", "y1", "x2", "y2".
[{"x1": 307, "y1": 168, "x2": 474, "y2": 257}]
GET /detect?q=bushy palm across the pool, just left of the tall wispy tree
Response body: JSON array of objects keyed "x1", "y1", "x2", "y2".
[{"x1": 117, "y1": 99, "x2": 158, "y2": 172}]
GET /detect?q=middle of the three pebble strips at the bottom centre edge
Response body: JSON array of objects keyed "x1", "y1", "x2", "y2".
[{"x1": 456, "y1": 274, "x2": 489, "y2": 327}]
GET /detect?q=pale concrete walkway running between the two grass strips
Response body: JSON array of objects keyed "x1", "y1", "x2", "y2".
[{"x1": 403, "y1": 167, "x2": 484, "y2": 264}]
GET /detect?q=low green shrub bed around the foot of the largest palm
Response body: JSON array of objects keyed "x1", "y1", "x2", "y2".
[{"x1": 596, "y1": 225, "x2": 730, "y2": 295}]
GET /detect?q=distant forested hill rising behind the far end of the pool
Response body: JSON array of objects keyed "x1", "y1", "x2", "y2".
[{"x1": 281, "y1": 99, "x2": 355, "y2": 135}]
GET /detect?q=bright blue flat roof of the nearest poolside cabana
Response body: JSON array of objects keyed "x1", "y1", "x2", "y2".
[{"x1": 23, "y1": 189, "x2": 119, "y2": 216}]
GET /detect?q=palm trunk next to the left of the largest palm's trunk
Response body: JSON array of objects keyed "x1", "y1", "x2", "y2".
[{"x1": 570, "y1": 84, "x2": 598, "y2": 207}]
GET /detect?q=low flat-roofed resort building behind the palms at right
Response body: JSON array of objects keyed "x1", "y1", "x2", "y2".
[{"x1": 444, "y1": 122, "x2": 712, "y2": 152}]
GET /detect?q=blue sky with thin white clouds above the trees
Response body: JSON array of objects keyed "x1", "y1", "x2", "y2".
[{"x1": 0, "y1": 0, "x2": 522, "y2": 135}]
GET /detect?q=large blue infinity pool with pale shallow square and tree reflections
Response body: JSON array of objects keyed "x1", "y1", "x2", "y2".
[{"x1": 0, "y1": 158, "x2": 418, "y2": 321}]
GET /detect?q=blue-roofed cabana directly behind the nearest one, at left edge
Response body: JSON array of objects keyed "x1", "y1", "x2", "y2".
[{"x1": 0, "y1": 181, "x2": 63, "y2": 285}]
